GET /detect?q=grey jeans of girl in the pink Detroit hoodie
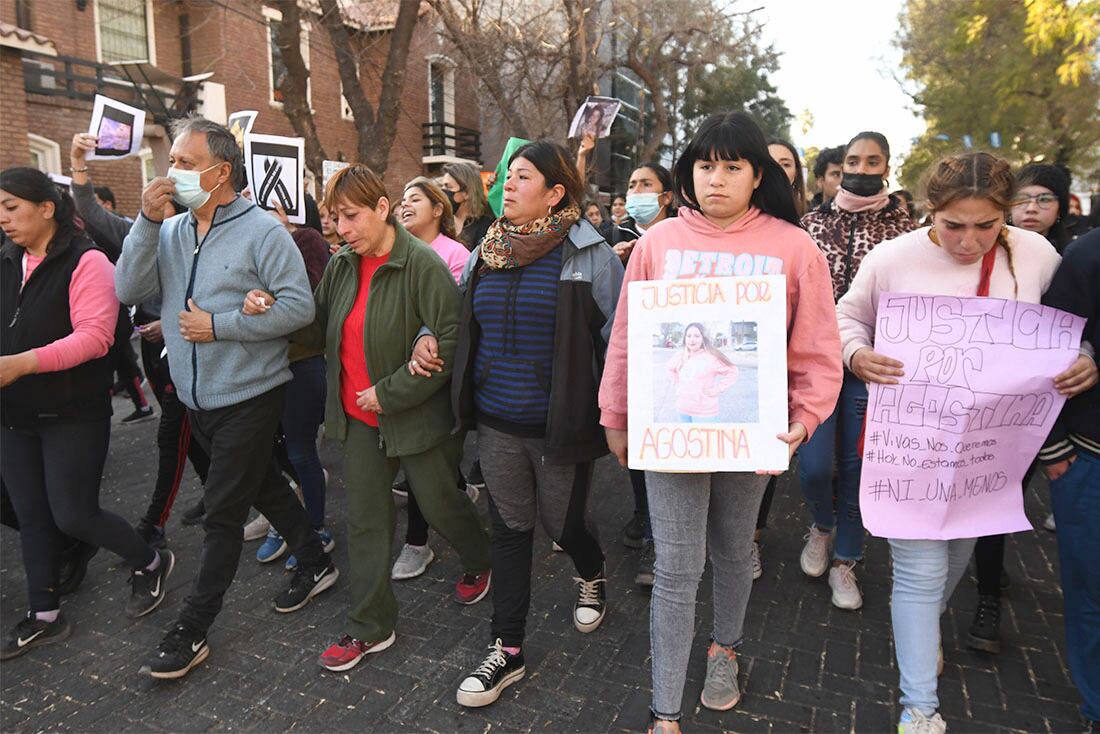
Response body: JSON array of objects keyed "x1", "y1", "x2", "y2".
[{"x1": 646, "y1": 471, "x2": 768, "y2": 719}]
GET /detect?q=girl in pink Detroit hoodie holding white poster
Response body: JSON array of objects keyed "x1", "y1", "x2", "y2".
[{"x1": 600, "y1": 112, "x2": 842, "y2": 734}]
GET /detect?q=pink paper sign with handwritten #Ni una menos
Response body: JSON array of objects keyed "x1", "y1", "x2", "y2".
[{"x1": 859, "y1": 293, "x2": 1085, "y2": 540}]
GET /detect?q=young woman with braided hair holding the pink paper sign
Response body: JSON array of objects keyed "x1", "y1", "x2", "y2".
[{"x1": 837, "y1": 153, "x2": 1096, "y2": 734}]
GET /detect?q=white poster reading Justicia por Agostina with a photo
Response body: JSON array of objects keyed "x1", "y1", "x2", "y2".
[{"x1": 627, "y1": 275, "x2": 788, "y2": 472}]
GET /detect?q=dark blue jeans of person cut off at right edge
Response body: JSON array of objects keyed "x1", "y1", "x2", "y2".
[{"x1": 1051, "y1": 451, "x2": 1100, "y2": 721}]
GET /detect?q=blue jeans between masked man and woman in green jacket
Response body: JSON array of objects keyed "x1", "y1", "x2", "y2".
[{"x1": 283, "y1": 355, "x2": 328, "y2": 530}]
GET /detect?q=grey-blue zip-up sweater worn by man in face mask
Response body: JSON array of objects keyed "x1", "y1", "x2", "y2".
[{"x1": 114, "y1": 196, "x2": 314, "y2": 410}]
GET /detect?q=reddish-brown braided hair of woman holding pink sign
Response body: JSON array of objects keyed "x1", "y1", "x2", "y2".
[{"x1": 925, "y1": 152, "x2": 1020, "y2": 295}]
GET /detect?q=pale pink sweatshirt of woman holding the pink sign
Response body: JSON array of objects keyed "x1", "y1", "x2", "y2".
[{"x1": 836, "y1": 227, "x2": 1062, "y2": 366}]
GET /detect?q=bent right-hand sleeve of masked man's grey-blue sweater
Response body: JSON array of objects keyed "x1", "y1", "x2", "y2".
[{"x1": 212, "y1": 227, "x2": 315, "y2": 341}]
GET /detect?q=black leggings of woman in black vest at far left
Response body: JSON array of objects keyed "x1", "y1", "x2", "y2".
[{"x1": 0, "y1": 418, "x2": 155, "y2": 612}]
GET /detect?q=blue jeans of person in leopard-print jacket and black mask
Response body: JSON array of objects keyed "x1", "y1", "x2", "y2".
[{"x1": 799, "y1": 370, "x2": 867, "y2": 561}]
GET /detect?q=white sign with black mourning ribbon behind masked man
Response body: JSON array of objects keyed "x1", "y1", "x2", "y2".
[{"x1": 244, "y1": 133, "x2": 306, "y2": 224}]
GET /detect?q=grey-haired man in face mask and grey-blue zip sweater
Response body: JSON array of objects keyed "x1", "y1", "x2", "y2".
[{"x1": 114, "y1": 118, "x2": 339, "y2": 678}]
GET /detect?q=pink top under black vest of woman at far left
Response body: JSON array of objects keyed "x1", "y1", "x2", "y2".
[{"x1": 23, "y1": 250, "x2": 119, "y2": 372}]
